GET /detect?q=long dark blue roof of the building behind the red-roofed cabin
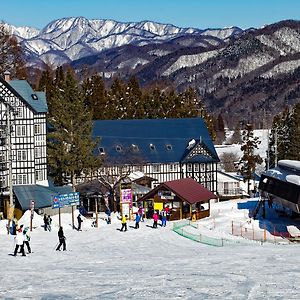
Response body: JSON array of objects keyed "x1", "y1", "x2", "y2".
[{"x1": 93, "y1": 118, "x2": 219, "y2": 164}]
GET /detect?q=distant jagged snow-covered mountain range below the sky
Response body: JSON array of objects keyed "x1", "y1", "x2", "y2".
[{"x1": 6, "y1": 17, "x2": 242, "y2": 66}]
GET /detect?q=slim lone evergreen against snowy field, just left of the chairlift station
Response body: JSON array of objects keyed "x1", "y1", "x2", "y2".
[{"x1": 239, "y1": 124, "x2": 263, "y2": 194}]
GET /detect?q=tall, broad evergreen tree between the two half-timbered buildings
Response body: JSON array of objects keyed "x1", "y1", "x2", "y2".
[{"x1": 48, "y1": 72, "x2": 100, "y2": 187}]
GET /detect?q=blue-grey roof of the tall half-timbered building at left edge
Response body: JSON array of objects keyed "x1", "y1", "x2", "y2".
[{"x1": 9, "y1": 80, "x2": 48, "y2": 113}]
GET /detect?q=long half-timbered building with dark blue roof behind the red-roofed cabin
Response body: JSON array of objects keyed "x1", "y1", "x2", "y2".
[{"x1": 91, "y1": 118, "x2": 219, "y2": 192}]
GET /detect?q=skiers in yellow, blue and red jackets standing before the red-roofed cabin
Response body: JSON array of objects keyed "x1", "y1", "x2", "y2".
[{"x1": 120, "y1": 206, "x2": 170, "y2": 231}]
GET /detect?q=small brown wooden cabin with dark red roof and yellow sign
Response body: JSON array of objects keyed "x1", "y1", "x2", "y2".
[{"x1": 138, "y1": 178, "x2": 217, "y2": 221}]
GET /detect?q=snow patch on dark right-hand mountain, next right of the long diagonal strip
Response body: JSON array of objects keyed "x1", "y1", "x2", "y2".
[{"x1": 214, "y1": 53, "x2": 274, "y2": 79}]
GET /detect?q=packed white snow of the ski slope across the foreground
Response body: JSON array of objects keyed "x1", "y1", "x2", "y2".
[{"x1": 0, "y1": 200, "x2": 300, "y2": 299}]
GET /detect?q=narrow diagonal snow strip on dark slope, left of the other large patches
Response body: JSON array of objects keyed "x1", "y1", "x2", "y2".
[{"x1": 162, "y1": 50, "x2": 218, "y2": 76}]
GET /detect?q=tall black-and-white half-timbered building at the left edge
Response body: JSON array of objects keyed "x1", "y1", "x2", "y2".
[{"x1": 0, "y1": 73, "x2": 48, "y2": 217}]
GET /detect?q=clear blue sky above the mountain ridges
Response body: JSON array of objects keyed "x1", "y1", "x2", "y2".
[{"x1": 0, "y1": 0, "x2": 300, "y2": 29}]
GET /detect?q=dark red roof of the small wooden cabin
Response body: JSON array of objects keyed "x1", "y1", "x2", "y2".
[{"x1": 139, "y1": 178, "x2": 218, "y2": 204}]
